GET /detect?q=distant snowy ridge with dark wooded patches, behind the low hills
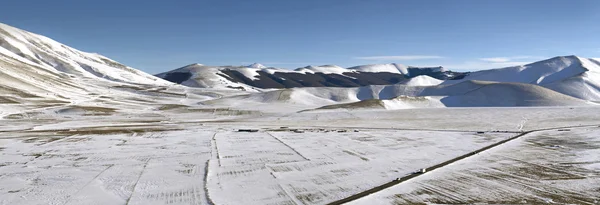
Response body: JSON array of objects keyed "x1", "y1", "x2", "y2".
[{"x1": 156, "y1": 63, "x2": 466, "y2": 90}]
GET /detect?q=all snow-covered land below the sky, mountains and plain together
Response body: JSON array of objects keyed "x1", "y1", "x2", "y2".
[{"x1": 0, "y1": 24, "x2": 600, "y2": 205}]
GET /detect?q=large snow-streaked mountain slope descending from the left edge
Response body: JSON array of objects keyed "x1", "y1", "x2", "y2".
[{"x1": 0, "y1": 21, "x2": 202, "y2": 117}]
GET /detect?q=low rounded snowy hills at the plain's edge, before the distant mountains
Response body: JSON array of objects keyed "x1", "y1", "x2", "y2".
[{"x1": 202, "y1": 80, "x2": 593, "y2": 110}]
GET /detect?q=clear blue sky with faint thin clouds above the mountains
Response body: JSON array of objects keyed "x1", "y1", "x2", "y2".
[{"x1": 0, "y1": 0, "x2": 600, "y2": 74}]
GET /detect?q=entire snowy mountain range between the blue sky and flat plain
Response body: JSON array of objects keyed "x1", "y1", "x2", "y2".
[{"x1": 0, "y1": 21, "x2": 600, "y2": 113}]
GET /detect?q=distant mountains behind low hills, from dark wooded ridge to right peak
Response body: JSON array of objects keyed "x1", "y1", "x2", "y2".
[{"x1": 158, "y1": 56, "x2": 600, "y2": 104}]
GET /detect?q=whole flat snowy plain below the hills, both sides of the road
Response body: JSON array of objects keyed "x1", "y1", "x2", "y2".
[{"x1": 0, "y1": 107, "x2": 600, "y2": 204}]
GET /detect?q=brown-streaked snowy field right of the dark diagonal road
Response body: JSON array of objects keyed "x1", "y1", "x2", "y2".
[{"x1": 349, "y1": 126, "x2": 600, "y2": 204}]
